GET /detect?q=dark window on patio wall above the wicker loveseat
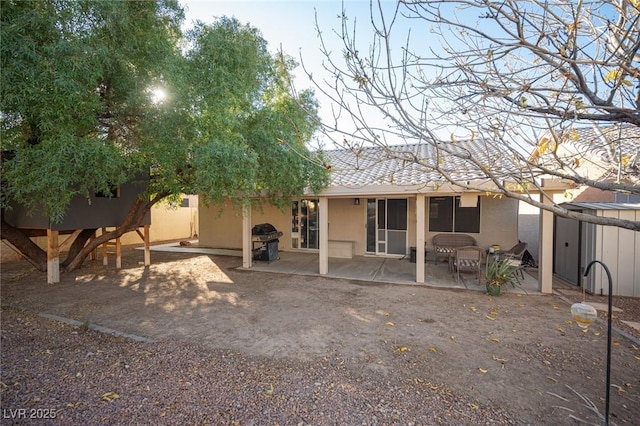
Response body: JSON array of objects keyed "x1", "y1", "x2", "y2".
[{"x1": 429, "y1": 197, "x2": 480, "y2": 233}]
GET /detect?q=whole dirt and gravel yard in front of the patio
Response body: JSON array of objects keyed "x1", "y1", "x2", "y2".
[{"x1": 0, "y1": 250, "x2": 640, "y2": 425}]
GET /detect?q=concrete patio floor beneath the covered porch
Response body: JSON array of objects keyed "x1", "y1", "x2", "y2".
[{"x1": 146, "y1": 241, "x2": 540, "y2": 294}]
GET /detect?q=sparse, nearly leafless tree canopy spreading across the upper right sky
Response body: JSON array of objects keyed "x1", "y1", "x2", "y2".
[{"x1": 307, "y1": 0, "x2": 640, "y2": 230}]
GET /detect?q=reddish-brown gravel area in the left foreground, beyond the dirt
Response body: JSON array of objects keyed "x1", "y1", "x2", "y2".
[{"x1": 2, "y1": 308, "x2": 514, "y2": 425}]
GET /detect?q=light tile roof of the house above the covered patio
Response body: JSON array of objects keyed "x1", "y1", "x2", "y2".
[{"x1": 325, "y1": 140, "x2": 512, "y2": 187}]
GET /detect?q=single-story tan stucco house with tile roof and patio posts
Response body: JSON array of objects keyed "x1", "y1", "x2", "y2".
[{"x1": 199, "y1": 141, "x2": 565, "y2": 293}]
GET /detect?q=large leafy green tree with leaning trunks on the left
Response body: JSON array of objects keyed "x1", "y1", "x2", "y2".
[{"x1": 0, "y1": 0, "x2": 327, "y2": 270}]
